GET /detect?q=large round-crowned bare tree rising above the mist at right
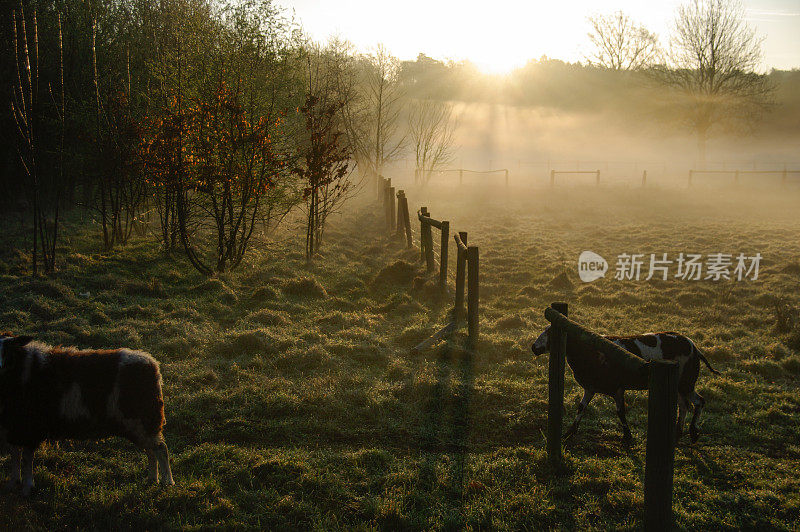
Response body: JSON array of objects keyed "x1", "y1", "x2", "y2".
[{"x1": 654, "y1": 0, "x2": 774, "y2": 165}]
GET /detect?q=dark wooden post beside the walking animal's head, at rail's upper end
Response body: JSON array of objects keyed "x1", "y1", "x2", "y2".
[{"x1": 547, "y1": 303, "x2": 568, "y2": 467}]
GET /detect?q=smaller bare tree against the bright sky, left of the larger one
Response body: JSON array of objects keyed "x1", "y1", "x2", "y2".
[{"x1": 587, "y1": 11, "x2": 659, "y2": 70}]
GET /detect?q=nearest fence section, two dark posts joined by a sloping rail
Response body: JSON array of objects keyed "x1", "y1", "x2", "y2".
[{"x1": 544, "y1": 303, "x2": 678, "y2": 530}]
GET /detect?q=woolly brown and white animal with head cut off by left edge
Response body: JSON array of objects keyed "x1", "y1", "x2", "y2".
[{"x1": 0, "y1": 333, "x2": 174, "y2": 496}]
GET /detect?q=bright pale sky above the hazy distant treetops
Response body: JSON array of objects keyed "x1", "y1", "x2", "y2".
[{"x1": 276, "y1": 0, "x2": 800, "y2": 73}]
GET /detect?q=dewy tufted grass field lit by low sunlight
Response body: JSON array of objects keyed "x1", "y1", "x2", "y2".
[{"x1": 0, "y1": 188, "x2": 800, "y2": 530}]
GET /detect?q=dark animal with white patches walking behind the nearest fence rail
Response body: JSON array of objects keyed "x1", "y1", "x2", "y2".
[{"x1": 531, "y1": 327, "x2": 720, "y2": 443}]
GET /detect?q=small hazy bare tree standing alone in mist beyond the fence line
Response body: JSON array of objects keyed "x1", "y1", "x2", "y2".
[{"x1": 408, "y1": 100, "x2": 456, "y2": 185}]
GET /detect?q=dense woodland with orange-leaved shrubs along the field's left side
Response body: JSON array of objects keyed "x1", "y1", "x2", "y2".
[{"x1": 0, "y1": 0, "x2": 460, "y2": 275}]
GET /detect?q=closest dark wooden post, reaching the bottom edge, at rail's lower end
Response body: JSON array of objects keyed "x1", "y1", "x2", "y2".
[{"x1": 644, "y1": 360, "x2": 678, "y2": 530}]
